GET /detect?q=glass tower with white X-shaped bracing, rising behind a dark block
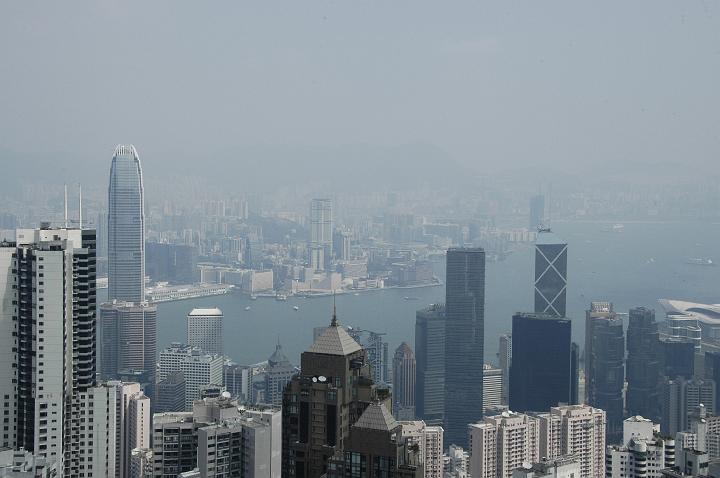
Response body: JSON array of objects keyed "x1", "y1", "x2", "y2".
[{"x1": 535, "y1": 229, "x2": 567, "y2": 317}]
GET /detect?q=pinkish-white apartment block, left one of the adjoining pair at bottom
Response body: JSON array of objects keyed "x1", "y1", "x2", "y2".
[{"x1": 468, "y1": 412, "x2": 540, "y2": 478}]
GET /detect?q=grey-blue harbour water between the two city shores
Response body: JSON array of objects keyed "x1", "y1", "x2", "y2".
[{"x1": 103, "y1": 222, "x2": 720, "y2": 364}]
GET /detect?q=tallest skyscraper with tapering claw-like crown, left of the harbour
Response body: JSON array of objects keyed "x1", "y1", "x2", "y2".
[{"x1": 107, "y1": 145, "x2": 145, "y2": 303}]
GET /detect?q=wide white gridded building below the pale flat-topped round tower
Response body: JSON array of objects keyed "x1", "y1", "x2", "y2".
[{"x1": 158, "y1": 343, "x2": 223, "y2": 411}]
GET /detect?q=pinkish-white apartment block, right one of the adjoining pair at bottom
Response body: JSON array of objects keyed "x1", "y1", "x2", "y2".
[{"x1": 537, "y1": 405, "x2": 605, "y2": 478}]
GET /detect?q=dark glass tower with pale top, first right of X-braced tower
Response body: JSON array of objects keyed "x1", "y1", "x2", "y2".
[{"x1": 586, "y1": 314, "x2": 625, "y2": 443}]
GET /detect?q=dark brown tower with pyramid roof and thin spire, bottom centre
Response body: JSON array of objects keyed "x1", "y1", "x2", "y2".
[{"x1": 282, "y1": 305, "x2": 391, "y2": 478}]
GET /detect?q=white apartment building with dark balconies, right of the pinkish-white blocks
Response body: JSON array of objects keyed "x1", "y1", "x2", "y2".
[{"x1": 605, "y1": 416, "x2": 677, "y2": 478}]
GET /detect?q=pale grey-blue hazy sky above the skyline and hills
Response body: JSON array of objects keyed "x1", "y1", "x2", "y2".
[{"x1": 0, "y1": 0, "x2": 720, "y2": 175}]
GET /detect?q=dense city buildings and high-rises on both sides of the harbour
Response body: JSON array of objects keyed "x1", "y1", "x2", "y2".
[{"x1": 0, "y1": 145, "x2": 720, "y2": 478}]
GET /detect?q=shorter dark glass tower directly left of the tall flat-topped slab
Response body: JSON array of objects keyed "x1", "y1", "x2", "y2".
[{"x1": 415, "y1": 304, "x2": 445, "y2": 426}]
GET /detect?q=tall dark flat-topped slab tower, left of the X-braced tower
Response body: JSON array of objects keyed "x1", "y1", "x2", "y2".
[{"x1": 445, "y1": 248, "x2": 485, "y2": 447}]
